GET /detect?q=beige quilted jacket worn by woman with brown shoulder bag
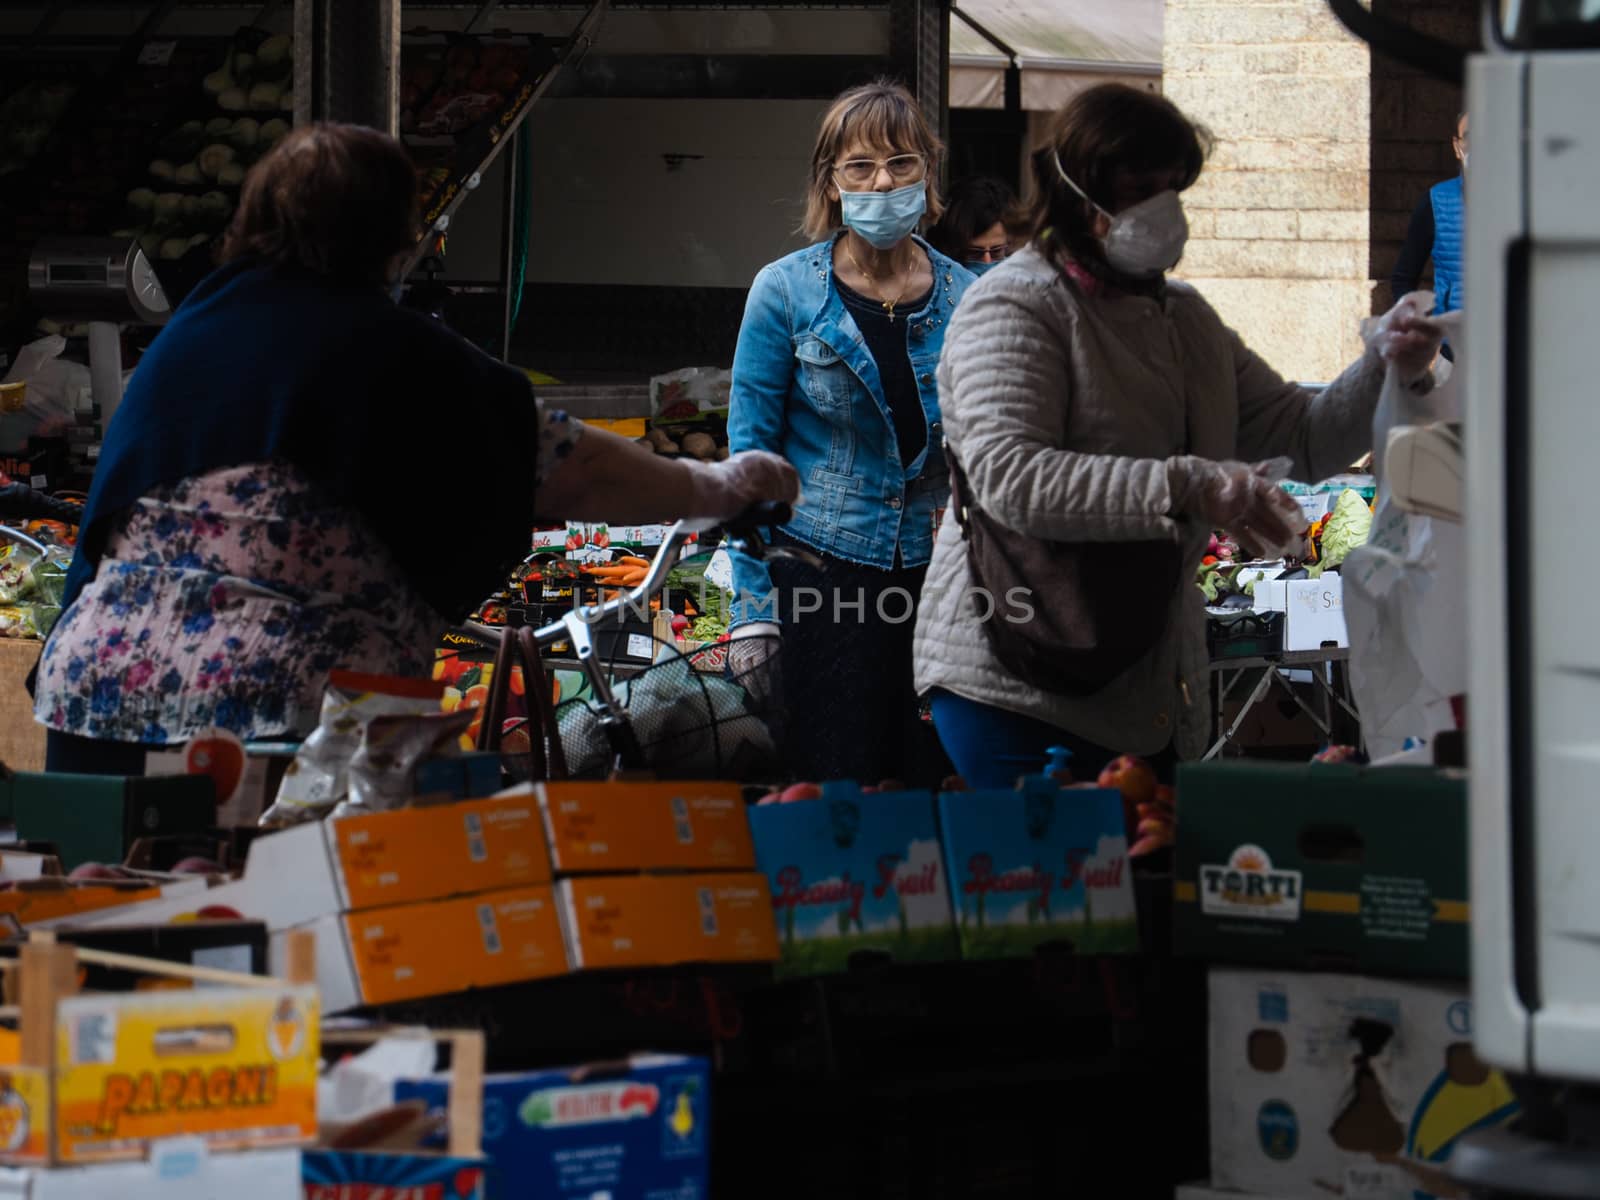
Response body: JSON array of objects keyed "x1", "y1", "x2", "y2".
[{"x1": 915, "y1": 248, "x2": 1384, "y2": 758}]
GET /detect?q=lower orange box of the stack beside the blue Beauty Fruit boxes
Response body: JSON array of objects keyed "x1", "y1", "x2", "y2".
[{"x1": 555, "y1": 872, "x2": 778, "y2": 970}]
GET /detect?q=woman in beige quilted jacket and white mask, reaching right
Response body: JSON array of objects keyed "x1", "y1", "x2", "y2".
[{"x1": 915, "y1": 85, "x2": 1438, "y2": 787}]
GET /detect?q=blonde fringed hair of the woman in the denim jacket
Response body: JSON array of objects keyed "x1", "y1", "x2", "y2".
[{"x1": 800, "y1": 80, "x2": 944, "y2": 242}]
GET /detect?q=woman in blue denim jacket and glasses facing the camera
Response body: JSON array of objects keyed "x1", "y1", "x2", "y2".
[{"x1": 728, "y1": 82, "x2": 973, "y2": 782}]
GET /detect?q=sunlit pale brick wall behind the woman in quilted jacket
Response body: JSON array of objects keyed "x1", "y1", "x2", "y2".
[{"x1": 1163, "y1": 0, "x2": 1387, "y2": 381}]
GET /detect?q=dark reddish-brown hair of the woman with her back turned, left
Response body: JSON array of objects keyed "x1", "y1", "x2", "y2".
[{"x1": 221, "y1": 123, "x2": 418, "y2": 283}]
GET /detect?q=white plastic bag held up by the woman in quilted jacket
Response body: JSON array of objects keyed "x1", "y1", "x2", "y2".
[{"x1": 1341, "y1": 312, "x2": 1467, "y2": 758}]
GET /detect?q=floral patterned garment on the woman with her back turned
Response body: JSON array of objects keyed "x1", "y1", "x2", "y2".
[{"x1": 34, "y1": 464, "x2": 445, "y2": 746}]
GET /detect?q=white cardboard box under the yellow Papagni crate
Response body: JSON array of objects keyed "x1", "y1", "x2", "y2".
[{"x1": 0, "y1": 1138, "x2": 302, "y2": 1200}]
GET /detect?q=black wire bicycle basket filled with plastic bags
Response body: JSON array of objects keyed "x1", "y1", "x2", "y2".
[{"x1": 555, "y1": 638, "x2": 779, "y2": 782}]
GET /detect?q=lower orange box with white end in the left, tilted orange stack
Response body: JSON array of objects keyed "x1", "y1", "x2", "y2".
[{"x1": 288, "y1": 886, "x2": 566, "y2": 1013}]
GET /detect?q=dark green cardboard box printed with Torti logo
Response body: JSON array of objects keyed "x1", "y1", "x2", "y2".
[{"x1": 1173, "y1": 762, "x2": 1470, "y2": 979}]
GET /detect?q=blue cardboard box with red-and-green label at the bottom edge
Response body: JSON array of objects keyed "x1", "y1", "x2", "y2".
[{"x1": 395, "y1": 1054, "x2": 710, "y2": 1200}]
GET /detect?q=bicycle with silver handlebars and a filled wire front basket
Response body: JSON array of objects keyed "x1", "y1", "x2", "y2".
[{"x1": 472, "y1": 504, "x2": 811, "y2": 779}]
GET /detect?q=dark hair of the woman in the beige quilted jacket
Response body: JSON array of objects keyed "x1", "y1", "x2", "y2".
[{"x1": 1024, "y1": 83, "x2": 1211, "y2": 267}]
